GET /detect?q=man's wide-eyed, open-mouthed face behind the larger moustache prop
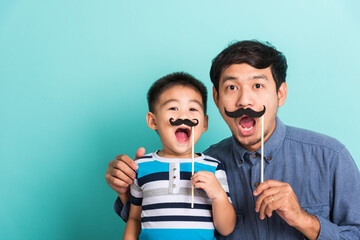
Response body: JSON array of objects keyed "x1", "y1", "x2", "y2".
[{"x1": 213, "y1": 63, "x2": 287, "y2": 152}]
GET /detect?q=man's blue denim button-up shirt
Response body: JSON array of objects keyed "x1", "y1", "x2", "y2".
[{"x1": 114, "y1": 118, "x2": 360, "y2": 239}]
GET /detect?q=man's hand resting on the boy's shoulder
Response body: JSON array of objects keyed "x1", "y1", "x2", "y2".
[{"x1": 105, "y1": 147, "x2": 145, "y2": 202}]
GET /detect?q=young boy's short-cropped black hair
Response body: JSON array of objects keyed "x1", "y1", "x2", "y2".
[{"x1": 147, "y1": 72, "x2": 207, "y2": 115}]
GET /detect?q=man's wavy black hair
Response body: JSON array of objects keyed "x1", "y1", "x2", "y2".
[{"x1": 210, "y1": 40, "x2": 287, "y2": 91}]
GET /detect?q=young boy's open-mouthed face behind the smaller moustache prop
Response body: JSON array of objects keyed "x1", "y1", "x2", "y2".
[{"x1": 146, "y1": 85, "x2": 208, "y2": 158}]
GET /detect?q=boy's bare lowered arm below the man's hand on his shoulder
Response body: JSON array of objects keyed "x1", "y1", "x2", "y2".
[{"x1": 123, "y1": 204, "x2": 142, "y2": 240}]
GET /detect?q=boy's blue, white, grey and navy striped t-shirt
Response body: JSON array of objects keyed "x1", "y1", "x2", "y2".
[{"x1": 130, "y1": 153, "x2": 230, "y2": 240}]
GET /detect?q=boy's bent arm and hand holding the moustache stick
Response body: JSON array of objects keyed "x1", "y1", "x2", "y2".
[{"x1": 191, "y1": 171, "x2": 236, "y2": 236}]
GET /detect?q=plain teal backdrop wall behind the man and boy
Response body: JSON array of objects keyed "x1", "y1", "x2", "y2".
[{"x1": 0, "y1": 0, "x2": 360, "y2": 239}]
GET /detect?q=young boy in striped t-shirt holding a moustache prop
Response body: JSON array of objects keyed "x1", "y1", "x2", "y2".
[{"x1": 123, "y1": 72, "x2": 236, "y2": 240}]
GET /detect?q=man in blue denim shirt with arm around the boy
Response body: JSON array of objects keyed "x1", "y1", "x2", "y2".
[{"x1": 106, "y1": 41, "x2": 360, "y2": 239}]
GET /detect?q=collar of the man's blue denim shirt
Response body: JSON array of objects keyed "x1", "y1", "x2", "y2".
[{"x1": 232, "y1": 117, "x2": 286, "y2": 165}]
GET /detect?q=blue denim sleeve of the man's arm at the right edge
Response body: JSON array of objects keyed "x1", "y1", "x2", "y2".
[{"x1": 315, "y1": 148, "x2": 360, "y2": 240}]
